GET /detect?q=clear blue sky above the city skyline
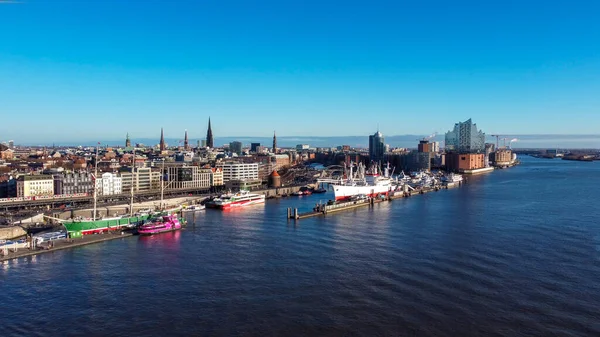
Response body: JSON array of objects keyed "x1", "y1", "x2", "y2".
[{"x1": 0, "y1": 0, "x2": 600, "y2": 143}]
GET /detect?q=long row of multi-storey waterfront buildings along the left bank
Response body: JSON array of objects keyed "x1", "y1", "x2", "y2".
[{"x1": 0, "y1": 158, "x2": 289, "y2": 198}]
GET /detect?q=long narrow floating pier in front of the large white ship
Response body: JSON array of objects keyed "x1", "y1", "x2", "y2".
[{"x1": 287, "y1": 183, "x2": 461, "y2": 220}]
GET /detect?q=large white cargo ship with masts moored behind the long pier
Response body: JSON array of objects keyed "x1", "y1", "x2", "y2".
[{"x1": 331, "y1": 163, "x2": 396, "y2": 201}]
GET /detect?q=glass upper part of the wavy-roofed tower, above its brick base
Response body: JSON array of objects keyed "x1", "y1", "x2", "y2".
[{"x1": 446, "y1": 119, "x2": 485, "y2": 153}]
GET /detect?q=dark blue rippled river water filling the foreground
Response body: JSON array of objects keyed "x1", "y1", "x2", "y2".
[{"x1": 0, "y1": 158, "x2": 600, "y2": 336}]
